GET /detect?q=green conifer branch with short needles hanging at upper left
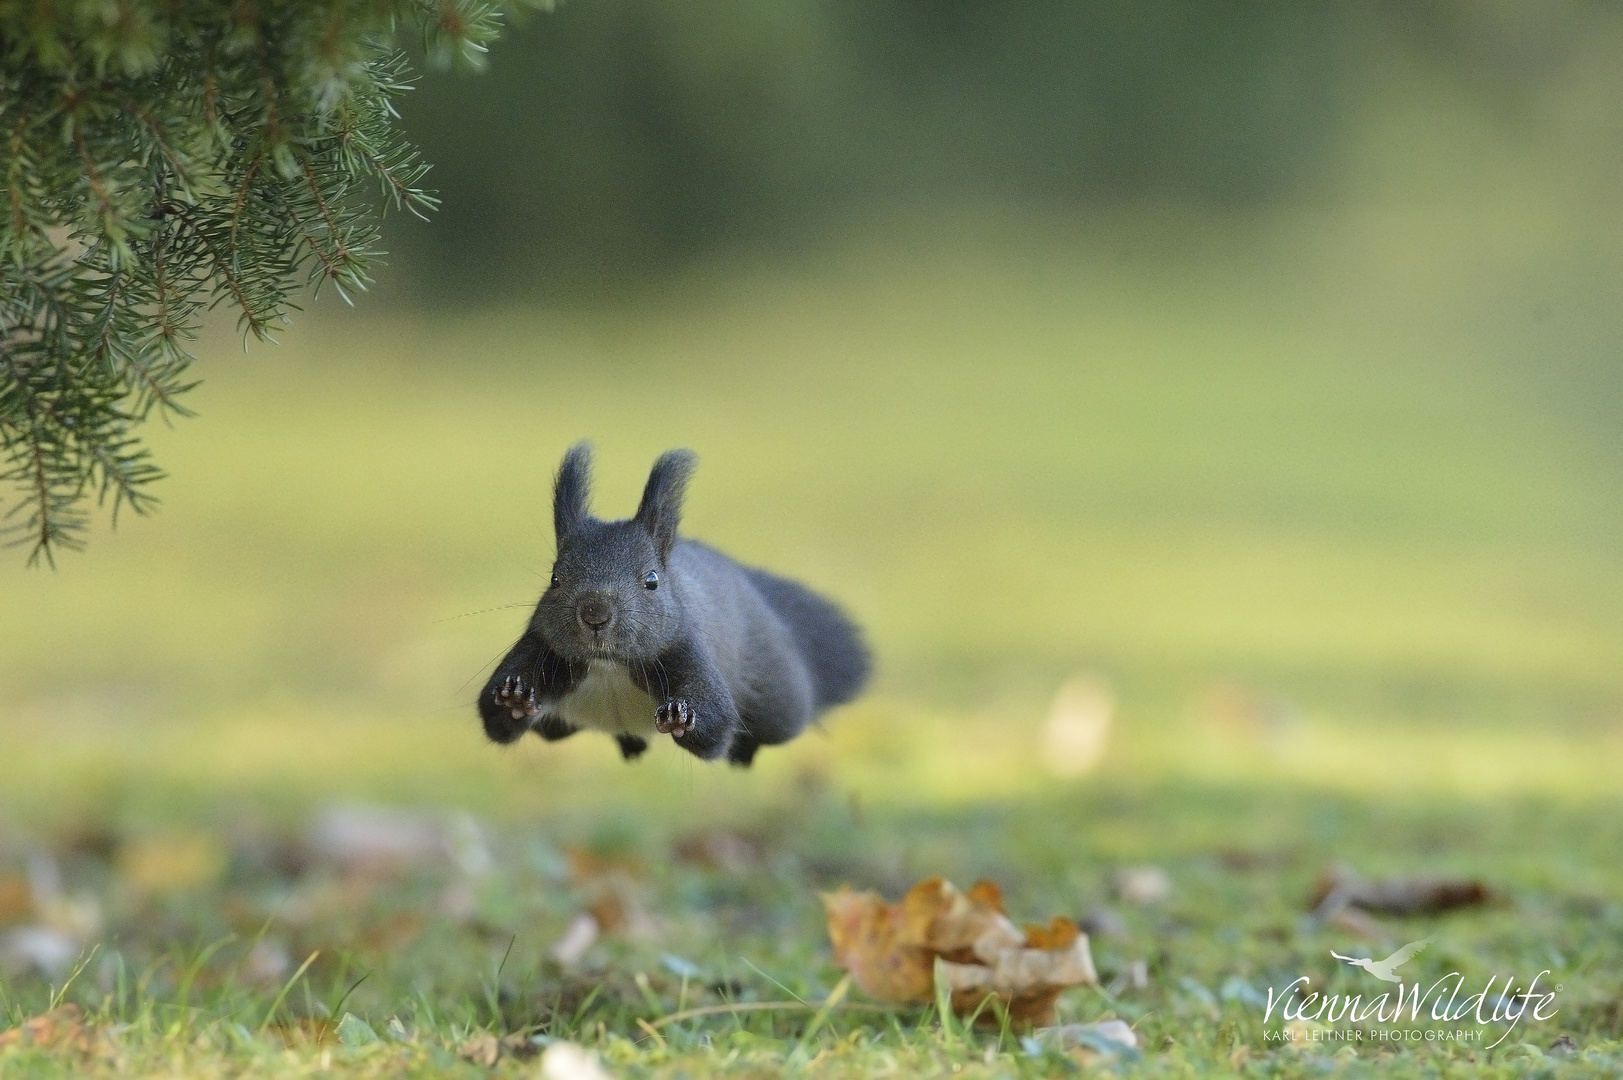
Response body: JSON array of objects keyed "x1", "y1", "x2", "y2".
[{"x1": 0, "y1": 0, "x2": 550, "y2": 565}]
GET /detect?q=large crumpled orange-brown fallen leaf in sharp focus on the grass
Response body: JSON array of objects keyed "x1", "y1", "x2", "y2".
[{"x1": 823, "y1": 877, "x2": 1099, "y2": 1026}]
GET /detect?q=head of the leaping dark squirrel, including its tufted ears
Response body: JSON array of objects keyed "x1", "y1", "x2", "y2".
[{"x1": 531, "y1": 442, "x2": 696, "y2": 663}]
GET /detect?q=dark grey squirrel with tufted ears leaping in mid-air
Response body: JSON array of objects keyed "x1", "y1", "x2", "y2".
[{"x1": 479, "y1": 443, "x2": 870, "y2": 765}]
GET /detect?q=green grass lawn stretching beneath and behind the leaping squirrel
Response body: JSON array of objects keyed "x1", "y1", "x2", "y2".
[{"x1": 0, "y1": 207, "x2": 1623, "y2": 1078}]
